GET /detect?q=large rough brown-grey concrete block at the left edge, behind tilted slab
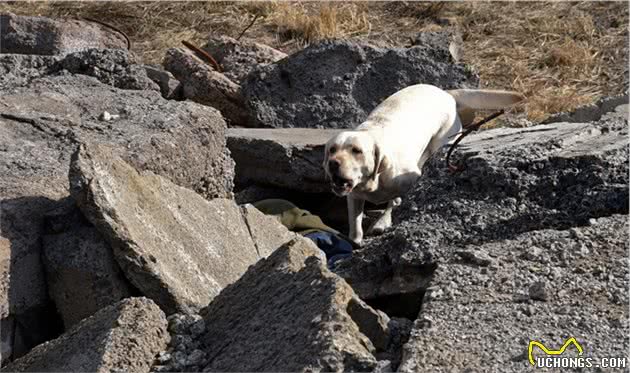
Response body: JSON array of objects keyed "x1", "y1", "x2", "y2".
[{"x1": 0, "y1": 75, "x2": 233, "y2": 198}]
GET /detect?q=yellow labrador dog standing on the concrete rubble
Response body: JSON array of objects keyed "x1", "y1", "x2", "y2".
[{"x1": 323, "y1": 84, "x2": 523, "y2": 243}]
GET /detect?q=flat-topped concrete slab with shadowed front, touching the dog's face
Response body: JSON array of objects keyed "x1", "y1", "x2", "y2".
[{"x1": 227, "y1": 128, "x2": 338, "y2": 193}]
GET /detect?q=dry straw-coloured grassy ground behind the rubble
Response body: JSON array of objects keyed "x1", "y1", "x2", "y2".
[{"x1": 0, "y1": 1, "x2": 628, "y2": 121}]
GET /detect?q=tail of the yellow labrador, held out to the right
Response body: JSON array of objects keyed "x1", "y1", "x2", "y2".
[{"x1": 447, "y1": 89, "x2": 525, "y2": 127}]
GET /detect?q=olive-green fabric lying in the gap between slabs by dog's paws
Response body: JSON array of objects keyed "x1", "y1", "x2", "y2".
[{"x1": 252, "y1": 199, "x2": 339, "y2": 235}]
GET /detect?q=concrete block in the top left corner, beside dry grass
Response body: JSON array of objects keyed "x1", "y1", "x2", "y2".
[{"x1": 0, "y1": 13, "x2": 127, "y2": 55}]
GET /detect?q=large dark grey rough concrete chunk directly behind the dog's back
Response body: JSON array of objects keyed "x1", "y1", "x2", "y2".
[{"x1": 242, "y1": 40, "x2": 478, "y2": 128}]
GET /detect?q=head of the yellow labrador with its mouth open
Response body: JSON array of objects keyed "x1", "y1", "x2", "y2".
[{"x1": 323, "y1": 131, "x2": 388, "y2": 196}]
